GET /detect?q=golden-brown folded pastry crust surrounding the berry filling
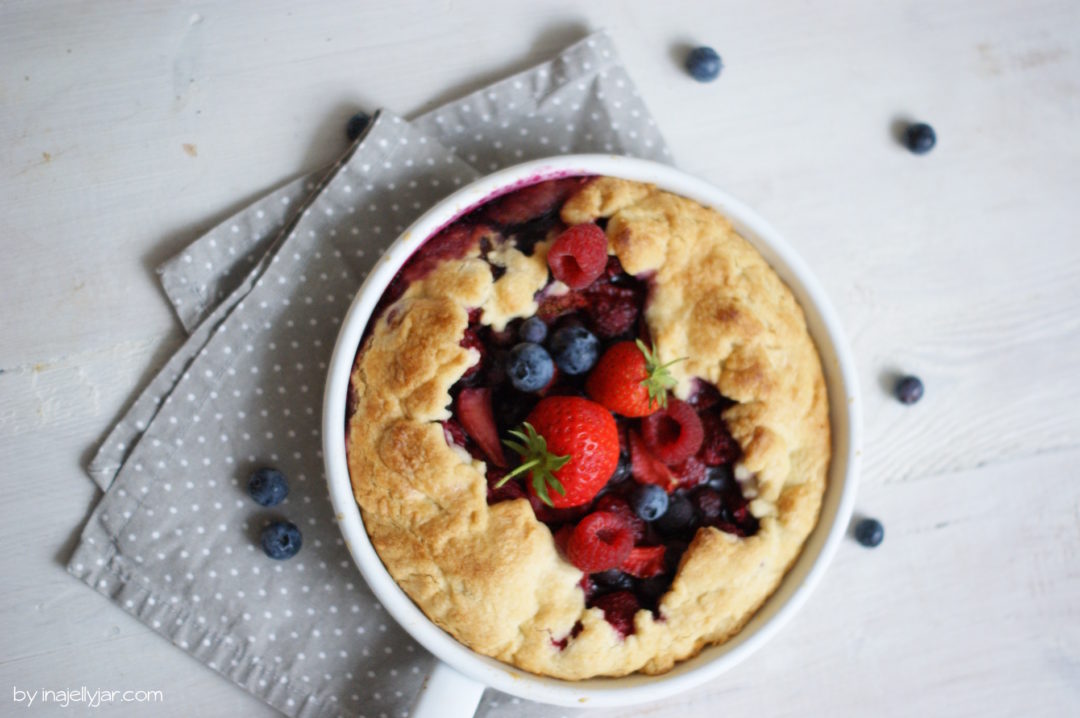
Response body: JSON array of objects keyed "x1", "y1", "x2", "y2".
[{"x1": 347, "y1": 177, "x2": 831, "y2": 680}]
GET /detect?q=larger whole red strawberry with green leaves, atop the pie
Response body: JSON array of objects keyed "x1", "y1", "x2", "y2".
[{"x1": 494, "y1": 396, "x2": 619, "y2": 509}]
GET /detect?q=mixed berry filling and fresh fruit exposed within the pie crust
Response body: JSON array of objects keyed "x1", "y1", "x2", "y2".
[{"x1": 380, "y1": 178, "x2": 758, "y2": 647}]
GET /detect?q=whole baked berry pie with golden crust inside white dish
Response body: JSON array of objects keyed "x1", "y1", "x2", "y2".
[{"x1": 346, "y1": 176, "x2": 831, "y2": 680}]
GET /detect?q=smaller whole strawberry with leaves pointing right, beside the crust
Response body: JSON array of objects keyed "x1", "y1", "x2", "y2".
[{"x1": 585, "y1": 339, "x2": 680, "y2": 417}]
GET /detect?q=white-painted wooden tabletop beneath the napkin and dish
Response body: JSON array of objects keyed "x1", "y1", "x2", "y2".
[{"x1": 0, "y1": 0, "x2": 1080, "y2": 717}]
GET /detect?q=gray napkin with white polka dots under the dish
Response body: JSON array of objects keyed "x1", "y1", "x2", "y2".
[{"x1": 68, "y1": 35, "x2": 667, "y2": 717}]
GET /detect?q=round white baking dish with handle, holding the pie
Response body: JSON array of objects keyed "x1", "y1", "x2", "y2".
[{"x1": 323, "y1": 154, "x2": 861, "y2": 716}]
